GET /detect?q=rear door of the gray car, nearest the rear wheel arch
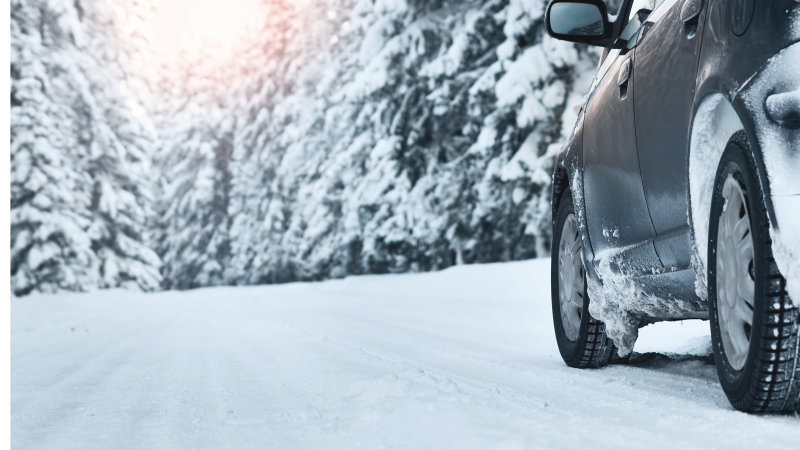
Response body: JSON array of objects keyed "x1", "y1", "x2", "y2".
[{"x1": 633, "y1": 0, "x2": 708, "y2": 268}]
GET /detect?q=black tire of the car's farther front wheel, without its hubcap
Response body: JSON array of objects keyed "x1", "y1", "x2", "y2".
[{"x1": 550, "y1": 190, "x2": 628, "y2": 369}]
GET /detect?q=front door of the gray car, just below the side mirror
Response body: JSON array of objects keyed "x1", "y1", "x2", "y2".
[{"x1": 583, "y1": 0, "x2": 661, "y2": 273}]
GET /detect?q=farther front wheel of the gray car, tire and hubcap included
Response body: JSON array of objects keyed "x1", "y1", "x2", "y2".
[{"x1": 550, "y1": 191, "x2": 627, "y2": 368}]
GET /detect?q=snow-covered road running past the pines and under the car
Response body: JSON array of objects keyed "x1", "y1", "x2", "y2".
[{"x1": 11, "y1": 260, "x2": 800, "y2": 450}]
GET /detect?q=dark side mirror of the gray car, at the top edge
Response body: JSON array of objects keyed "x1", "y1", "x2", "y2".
[{"x1": 545, "y1": 0, "x2": 613, "y2": 47}]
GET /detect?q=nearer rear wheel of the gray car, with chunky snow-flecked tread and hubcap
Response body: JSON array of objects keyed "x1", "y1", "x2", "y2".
[{"x1": 707, "y1": 133, "x2": 800, "y2": 412}]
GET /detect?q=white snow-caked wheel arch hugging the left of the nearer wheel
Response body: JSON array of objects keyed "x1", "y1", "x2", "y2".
[{"x1": 687, "y1": 94, "x2": 744, "y2": 299}]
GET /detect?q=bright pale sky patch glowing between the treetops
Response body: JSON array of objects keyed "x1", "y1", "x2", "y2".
[{"x1": 153, "y1": 0, "x2": 260, "y2": 54}]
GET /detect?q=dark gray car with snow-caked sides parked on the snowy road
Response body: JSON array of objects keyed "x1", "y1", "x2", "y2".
[{"x1": 546, "y1": 0, "x2": 800, "y2": 412}]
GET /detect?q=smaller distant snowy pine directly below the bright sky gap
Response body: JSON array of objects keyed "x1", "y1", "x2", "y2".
[{"x1": 156, "y1": 85, "x2": 233, "y2": 289}]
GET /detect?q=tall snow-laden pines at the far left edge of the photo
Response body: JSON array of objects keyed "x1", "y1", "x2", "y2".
[{"x1": 11, "y1": 0, "x2": 161, "y2": 295}]
